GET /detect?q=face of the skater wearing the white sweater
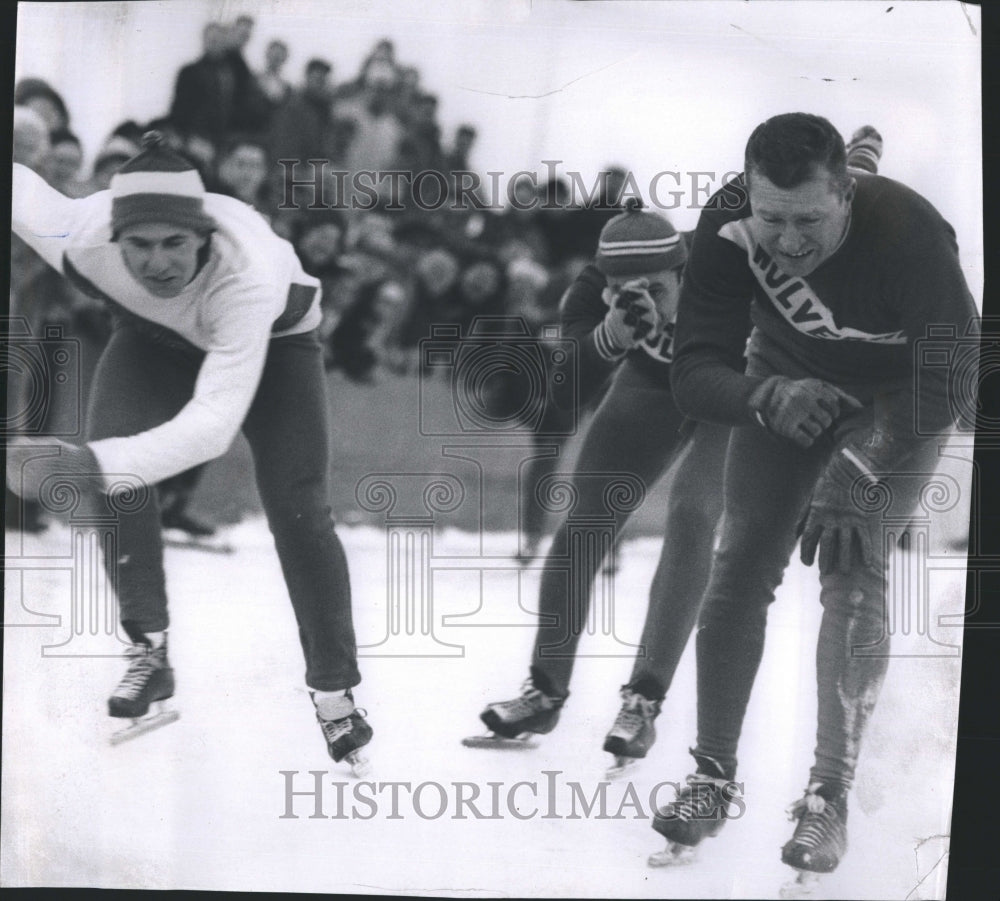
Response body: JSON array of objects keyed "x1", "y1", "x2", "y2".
[{"x1": 118, "y1": 222, "x2": 208, "y2": 297}]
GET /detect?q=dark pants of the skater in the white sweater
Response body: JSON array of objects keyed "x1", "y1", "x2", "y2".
[{"x1": 88, "y1": 325, "x2": 361, "y2": 691}]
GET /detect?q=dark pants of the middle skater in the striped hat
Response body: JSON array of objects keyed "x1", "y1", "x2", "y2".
[{"x1": 532, "y1": 360, "x2": 729, "y2": 694}]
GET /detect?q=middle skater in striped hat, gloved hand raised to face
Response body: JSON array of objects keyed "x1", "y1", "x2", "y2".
[{"x1": 466, "y1": 204, "x2": 729, "y2": 775}]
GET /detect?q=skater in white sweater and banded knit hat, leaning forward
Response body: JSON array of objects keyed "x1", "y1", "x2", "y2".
[{"x1": 8, "y1": 132, "x2": 372, "y2": 761}]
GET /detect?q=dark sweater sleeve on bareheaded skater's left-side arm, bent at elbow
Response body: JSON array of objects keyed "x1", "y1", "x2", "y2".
[{"x1": 671, "y1": 188, "x2": 763, "y2": 425}]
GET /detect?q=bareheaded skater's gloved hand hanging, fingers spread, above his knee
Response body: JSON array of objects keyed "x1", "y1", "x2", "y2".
[{"x1": 800, "y1": 444, "x2": 878, "y2": 574}]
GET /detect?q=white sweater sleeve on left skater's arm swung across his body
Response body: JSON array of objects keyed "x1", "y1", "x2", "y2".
[{"x1": 84, "y1": 277, "x2": 274, "y2": 487}]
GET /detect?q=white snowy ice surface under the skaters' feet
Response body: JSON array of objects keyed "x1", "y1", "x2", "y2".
[{"x1": 0, "y1": 510, "x2": 964, "y2": 899}]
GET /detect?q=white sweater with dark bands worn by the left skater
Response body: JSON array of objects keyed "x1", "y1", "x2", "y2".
[{"x1": 11, "y1": 164, "x2": 320, "y2": 485}]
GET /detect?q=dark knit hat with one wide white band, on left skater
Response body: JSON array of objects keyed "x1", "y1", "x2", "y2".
[{"x1": 110, "y1": 131, "x2": 216, "y2": 235}]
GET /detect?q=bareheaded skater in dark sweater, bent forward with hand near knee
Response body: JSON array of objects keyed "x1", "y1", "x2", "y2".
[{"x1": 653, "y1": 113, "x2": 978, "y2": 895}]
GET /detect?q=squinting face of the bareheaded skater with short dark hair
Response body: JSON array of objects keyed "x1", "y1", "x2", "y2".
[{"x1": 748, "y1": 169, "x2": 856, "y2": 276}]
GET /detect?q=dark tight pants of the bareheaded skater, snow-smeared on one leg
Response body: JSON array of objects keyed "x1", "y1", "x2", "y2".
[{"x1": 696, "y1": 326, "x2": 938, "y2": 786}]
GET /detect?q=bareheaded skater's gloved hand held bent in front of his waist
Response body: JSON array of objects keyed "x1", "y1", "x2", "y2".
[{"x1": 750, "y1": 375, "x2": 862, "y2": 447}]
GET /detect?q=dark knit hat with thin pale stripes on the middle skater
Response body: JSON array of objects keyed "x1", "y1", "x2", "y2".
[{"x1": 595, "y1": 197, "x2": 687, "y2": 275}]
